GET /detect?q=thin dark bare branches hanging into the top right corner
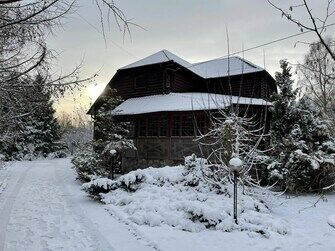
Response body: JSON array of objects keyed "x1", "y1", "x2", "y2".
[{"x1": 268, "y1": 0, "x2": 335, "y2": 60}]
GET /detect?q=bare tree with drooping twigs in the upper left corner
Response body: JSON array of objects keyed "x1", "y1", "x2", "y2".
[{"x1": 0, "y1": 0, "x2": 135, "y2": 145}]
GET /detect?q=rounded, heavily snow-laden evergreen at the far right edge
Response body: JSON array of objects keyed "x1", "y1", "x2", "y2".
[{"x1": 283, "y1": 97, "x2": 335, "y2": 192}]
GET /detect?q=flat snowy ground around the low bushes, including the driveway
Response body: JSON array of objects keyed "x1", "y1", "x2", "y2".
[{"x1": 0, "y1": 159, "x2": 335, "y2": 251}]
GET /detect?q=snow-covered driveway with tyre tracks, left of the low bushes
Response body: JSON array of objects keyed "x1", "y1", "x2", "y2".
[{"x1": 0, "y1": 159, "x2": 152, "y2": 250}]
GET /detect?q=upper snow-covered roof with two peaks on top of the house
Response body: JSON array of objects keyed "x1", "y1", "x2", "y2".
[{"x1": 121, "y1": 50, "x2": 264, "y2": 78}]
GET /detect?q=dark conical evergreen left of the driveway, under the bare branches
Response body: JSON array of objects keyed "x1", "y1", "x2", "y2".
[{"x1": 0, "y1": 75, "x2": 64, "y2": 159}]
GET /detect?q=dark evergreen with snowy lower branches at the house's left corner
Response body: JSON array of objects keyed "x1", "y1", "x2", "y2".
[{"x1": 72, "y1": 89, "x2": 135, "y2": 181}]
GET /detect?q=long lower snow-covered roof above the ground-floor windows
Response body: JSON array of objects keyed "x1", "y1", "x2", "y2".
[{"x1": 111, "y1": 92, "x2": 271, "y2": 115}]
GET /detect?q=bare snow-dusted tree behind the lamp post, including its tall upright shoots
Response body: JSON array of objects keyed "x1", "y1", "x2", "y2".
[{"x1": 197, "y1": 31, "x2": 268, "y2": 188}]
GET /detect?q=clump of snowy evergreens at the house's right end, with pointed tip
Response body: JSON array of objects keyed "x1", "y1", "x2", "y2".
[{"x1": 268, "y1": 61, "x2": 335, "y2": 192}]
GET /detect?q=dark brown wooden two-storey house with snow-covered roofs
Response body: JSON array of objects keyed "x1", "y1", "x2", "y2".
[{"x1": 88, "y1": 50, "x2": 277, "y2": 173}]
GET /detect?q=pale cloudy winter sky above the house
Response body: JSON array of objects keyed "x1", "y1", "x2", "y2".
[{"x1": 48, "y1": 0, "x2": 334, "y2": 117}]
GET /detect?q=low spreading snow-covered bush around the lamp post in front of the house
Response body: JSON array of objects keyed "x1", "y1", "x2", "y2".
[{"x1": 83, "y1": 155, "x2": 289, "y2": 237}]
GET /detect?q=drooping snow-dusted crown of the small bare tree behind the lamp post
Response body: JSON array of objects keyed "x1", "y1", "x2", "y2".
[{"x1": 197, "y1": 99, "x2": 268, "y2": 190}]
